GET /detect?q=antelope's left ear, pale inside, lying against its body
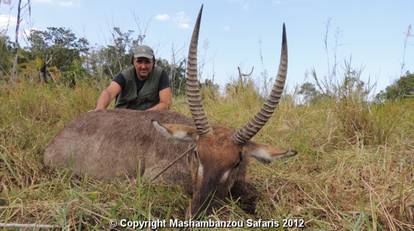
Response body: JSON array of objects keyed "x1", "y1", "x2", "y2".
[{"x1": 151, "y1": 120, "x2": 198, "y2": 141}]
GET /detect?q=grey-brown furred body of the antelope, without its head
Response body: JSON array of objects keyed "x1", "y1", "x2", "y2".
[{"x1": 44, "y1": 109, "x2": 192, "y2": 187}]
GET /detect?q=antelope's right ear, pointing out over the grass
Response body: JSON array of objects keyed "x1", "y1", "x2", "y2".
[{"x1": 242, "y1": 142, "x2": 297, "y2": 163}]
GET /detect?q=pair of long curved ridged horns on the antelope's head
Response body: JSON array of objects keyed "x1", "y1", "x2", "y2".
[{"x1": 186, "y1": 6, "x2": 288, "y2": 144}]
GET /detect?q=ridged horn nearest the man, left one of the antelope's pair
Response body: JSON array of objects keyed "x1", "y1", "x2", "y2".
[{"x1": 186, "y1": 5, "x2": 213, "y2": 136}]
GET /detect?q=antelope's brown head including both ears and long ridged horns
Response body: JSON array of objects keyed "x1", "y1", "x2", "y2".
[{"x1": 153, "y1": 7, "x2": 296, "y2": 216}]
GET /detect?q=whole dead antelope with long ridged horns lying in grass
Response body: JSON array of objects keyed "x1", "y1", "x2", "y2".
[{"x1": 44, "y1": 7, "x2": 297, "y2": 216}]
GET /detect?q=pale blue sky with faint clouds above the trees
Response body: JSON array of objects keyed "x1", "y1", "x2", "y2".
[{"x1": 0, "y1": 0, "x2": 414, "y2": 93}]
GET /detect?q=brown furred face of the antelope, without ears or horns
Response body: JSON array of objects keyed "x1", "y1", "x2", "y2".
[{"x1": 185, "y1": 126, "x2": 255, "y2": 215}]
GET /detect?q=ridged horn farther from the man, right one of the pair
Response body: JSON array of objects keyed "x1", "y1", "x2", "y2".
[{"x1": 233, "y1": 24, "x2": 288, "y2": 144}]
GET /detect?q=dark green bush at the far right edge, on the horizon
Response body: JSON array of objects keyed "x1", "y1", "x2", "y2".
[{"x1": 376, "y1": 72, "x2": 414, "y2": 102}]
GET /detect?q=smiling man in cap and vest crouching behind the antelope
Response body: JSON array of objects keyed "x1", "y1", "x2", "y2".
[{"x1": 95, "y1": 45, "x2": 172, "y2": 110}]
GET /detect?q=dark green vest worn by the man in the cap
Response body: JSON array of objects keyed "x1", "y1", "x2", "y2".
[{"x1": 115, "y1": 66, "x2": 162, "y2": 110}]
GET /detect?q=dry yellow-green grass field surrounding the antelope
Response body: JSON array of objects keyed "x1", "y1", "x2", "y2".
[{"x1": 0, "y1": 81, "x2": 414, "y2": 230}]
